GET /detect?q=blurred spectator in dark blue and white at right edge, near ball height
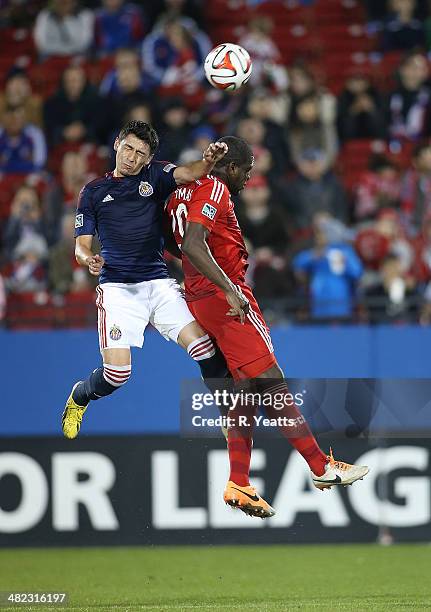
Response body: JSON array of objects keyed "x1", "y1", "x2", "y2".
[{"x1": 389, "y1": 53, "x2": 431, "y2": 140}]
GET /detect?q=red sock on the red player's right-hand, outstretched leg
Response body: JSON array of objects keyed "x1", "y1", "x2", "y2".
[{"x1": 260, "y1": 379, "x2": 328, "y2": 476}]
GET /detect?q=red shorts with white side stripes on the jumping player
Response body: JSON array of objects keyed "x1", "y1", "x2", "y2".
[{"x1": 188, "y1": 285, "x2": 276, "y2": 380}]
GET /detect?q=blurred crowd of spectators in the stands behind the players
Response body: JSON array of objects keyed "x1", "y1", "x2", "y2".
[{"x1": 0, "y1": 0, "x2": 431, "y2": 324}]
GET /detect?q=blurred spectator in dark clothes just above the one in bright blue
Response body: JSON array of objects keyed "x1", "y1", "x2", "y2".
[{"x1": 284, "y1": 149, "x2": 349, "y2": 231}]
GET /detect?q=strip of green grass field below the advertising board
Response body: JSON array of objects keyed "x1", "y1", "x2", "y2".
[{"x1": 0, "y1": 545, "x2": 431, "y2": 612}]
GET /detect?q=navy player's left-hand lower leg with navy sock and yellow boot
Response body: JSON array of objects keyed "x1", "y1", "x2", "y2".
[{"x1": 61, "y1": 347, "x2": 132, "y2": 439}]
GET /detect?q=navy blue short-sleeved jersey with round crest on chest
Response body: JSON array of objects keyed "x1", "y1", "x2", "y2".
[{"x1": 75, "y1": 162, "x2": 177, "y2": 283}]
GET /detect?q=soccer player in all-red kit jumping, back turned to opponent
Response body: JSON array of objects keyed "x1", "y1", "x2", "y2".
[{"x1": 167, "y1": 136, "x2": 368, "y2": 518}]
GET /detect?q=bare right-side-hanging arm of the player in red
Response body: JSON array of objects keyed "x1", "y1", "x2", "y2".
[{"x1": 181, "y1": 222, "x2": 249, "y2": 323}]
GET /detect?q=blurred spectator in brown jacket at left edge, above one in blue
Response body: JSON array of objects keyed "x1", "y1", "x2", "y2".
[{"x1": 0, "y1": 66, "x2": 42, "y2": 127}]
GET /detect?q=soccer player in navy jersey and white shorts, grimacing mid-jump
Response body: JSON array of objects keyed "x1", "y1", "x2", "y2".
[{"x1": 62, "y1": 121, "x2": 231, "y2": 438}]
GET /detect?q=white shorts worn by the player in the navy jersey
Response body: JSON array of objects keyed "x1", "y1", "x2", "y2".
[{"x1": 96, "y1": 278, "x2": 194, "y2": 350}]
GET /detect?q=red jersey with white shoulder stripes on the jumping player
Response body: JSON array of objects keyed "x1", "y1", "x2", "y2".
[{"x1": 166, "y1": 175, "x2": 248, "y2": 301}]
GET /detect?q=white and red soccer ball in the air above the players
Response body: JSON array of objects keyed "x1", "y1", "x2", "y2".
[{"x1": 204, "y1": 43, "x2": 252, "y2": 91}]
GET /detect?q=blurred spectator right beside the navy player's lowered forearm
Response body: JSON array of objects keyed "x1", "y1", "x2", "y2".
[{"x1": 48, "y1": 212, "x2": 94, "y2": 294}]
